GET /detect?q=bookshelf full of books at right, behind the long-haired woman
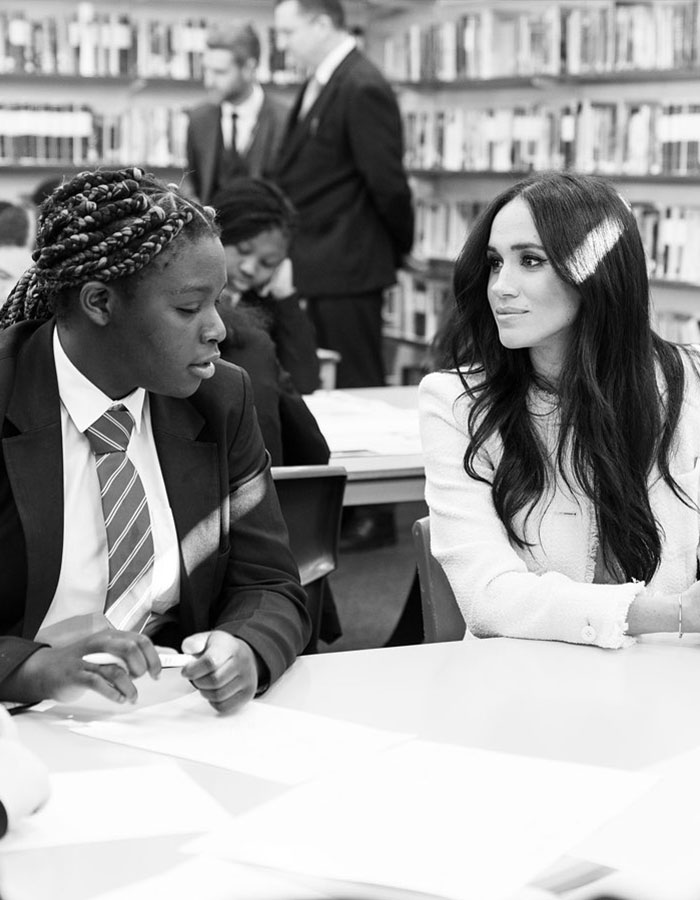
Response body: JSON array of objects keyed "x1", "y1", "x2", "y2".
[{"x1": 368, "y1": 0, "x2": 700, "y2": 379}]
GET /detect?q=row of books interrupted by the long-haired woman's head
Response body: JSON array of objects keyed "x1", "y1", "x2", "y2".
[{"x1": 414, "y1": 200, "x2": 700, "y2": 285}]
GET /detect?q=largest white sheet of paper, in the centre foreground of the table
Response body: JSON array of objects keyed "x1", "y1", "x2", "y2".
[{"x1": 184, "y1": 741, "x2": 654, "y2": 900}]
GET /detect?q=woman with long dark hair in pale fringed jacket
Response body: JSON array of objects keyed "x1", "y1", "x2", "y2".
[{"x1": 420, "y1": 173, "x2": 700, "y2": 648}]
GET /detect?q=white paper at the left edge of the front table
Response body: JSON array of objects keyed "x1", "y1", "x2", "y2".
[{"x1": 0, "y1": 762, "x2": 231, "y2": 856}]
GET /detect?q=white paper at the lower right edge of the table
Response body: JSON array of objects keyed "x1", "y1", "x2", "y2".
[{"x1": 572, "y1": 748, "x2": 700, "y2": 884}]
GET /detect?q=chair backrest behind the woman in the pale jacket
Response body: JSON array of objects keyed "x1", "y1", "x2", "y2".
[{"x1": 413, "y1": 516, "x2": 466, "y2": 644}]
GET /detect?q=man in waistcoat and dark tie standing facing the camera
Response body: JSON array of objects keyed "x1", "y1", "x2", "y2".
[{"x1": 187, "y1": 24, "x2": 287, "y2": 203}]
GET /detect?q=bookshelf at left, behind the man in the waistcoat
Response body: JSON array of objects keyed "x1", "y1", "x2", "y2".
[{"x1": 0, "y1": 0, "x2": 378, "y2": 202}]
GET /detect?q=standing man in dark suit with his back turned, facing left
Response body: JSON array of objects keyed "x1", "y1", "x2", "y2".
[{"x1": 275, "y1": 0, "x2": 414, "y2": 551}]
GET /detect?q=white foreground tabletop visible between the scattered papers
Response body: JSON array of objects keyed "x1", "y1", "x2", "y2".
[{"x1": 0, "y1": 637, "x2": 700, "y2": 900}]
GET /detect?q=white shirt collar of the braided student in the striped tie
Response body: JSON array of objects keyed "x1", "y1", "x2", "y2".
[{"x1": 53, "y1": 327, "x2": 146, "y2": 432}]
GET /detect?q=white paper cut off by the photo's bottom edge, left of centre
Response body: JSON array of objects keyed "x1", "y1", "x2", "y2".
[{"x1": 87, "y1": 857, "x2": 327, "y2": 900}]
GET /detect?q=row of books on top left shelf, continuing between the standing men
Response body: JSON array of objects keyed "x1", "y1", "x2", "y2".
[{"x1": 0, "y1": 3, "x2": 298, "y2": 82}]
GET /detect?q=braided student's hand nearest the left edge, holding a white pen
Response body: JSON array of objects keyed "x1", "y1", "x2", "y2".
[{"x1": 6, "y1": 628, "x2": 160, "y2": 703}]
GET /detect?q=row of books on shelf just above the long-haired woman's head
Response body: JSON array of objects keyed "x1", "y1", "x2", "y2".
[{"x1": 403, "y1": 100, "x2": 700, "y2": 175}]
